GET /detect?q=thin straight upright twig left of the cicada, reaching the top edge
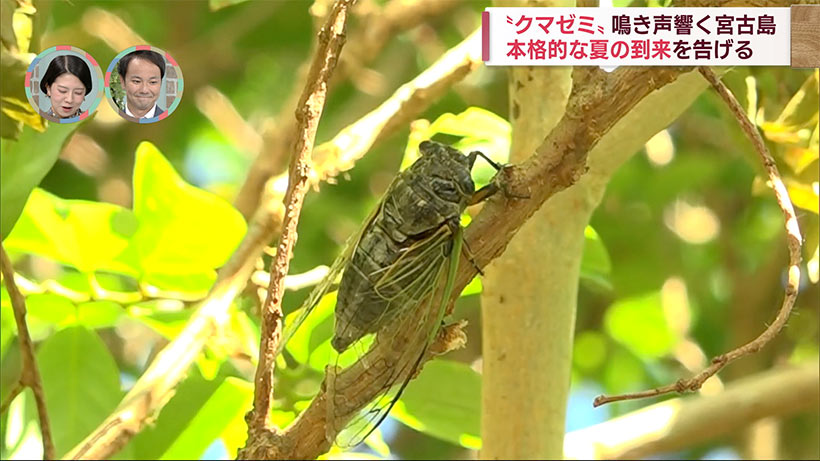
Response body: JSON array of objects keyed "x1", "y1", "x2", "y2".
[{"x1": 240, "y1": 0, "x2": 353, "y2": 446}]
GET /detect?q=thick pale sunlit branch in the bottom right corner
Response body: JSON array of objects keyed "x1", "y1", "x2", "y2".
[{"x1": 564, "y1": 363, "x2": 820, "y2": 459}]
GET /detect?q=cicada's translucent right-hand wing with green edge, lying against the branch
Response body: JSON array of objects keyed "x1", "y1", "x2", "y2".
[{"x1": 326, "y1": 222, "x2": 460, "y2": 448}]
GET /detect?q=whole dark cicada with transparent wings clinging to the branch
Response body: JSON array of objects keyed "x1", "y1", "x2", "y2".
[{"x1": 282, "y1": 141, "x2": 501, "y2": 447}]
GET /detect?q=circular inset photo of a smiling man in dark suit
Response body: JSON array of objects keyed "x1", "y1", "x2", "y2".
[{"x1": 105, "y1": 45, "x2": 182, "y2": 123}]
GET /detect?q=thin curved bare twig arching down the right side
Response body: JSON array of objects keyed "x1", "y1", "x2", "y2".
[{"x1": 592, "y1": 67, "x2": 803, "y2": 407}]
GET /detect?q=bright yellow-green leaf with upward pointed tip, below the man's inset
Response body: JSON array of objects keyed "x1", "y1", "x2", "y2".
[{"x1": 134, "y1": 142, "x2": 246, "y2": 274}]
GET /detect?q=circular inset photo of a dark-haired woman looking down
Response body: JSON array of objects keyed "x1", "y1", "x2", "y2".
[{"x1": 26, "y1": 46, "x2": 103, "y2": 123}]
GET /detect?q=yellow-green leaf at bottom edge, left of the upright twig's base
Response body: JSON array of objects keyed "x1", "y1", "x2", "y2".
[{"x1": 158, "y1": 378, "x2": 253, "y2": 459}]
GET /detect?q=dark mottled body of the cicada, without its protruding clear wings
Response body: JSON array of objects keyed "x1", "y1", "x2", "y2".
[{"x1": 331, "y1": 141, "x2": 484, "y2": 352}]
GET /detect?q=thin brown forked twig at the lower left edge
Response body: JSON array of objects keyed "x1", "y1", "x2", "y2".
[{"x1": 0, "y1": 237, "x2": 54, "y2": 459}]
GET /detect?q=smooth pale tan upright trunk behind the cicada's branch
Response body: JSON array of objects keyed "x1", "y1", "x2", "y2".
[{"x1": 481, "y1": 60, "x2": 572, "y2": 459}]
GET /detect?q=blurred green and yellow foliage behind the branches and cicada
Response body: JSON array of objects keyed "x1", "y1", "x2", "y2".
[{"x1": 0, "y1": 0, "x2": 820, "y2": 459}]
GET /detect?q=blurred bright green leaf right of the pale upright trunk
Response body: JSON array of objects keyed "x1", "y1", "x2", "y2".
[{"x1": 604, "y1": 292, "x2": 679, "y2": 358}]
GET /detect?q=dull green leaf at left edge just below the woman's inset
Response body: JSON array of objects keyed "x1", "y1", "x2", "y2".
[{"x1": 0, "y1": 122, "x2": 82, "y2": 239}]
